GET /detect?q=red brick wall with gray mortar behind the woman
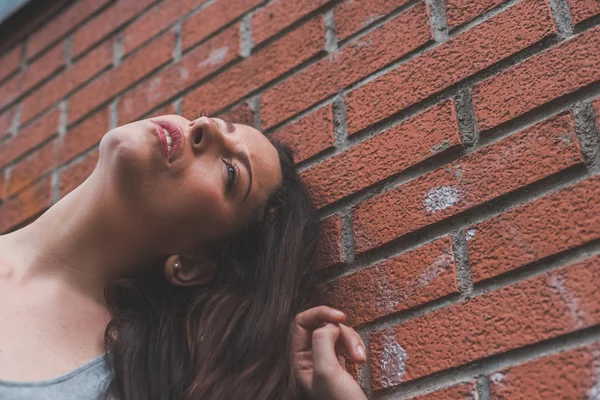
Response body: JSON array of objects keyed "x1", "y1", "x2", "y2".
[{"x1": 0, "y1": 0, "x2": 600, "y2": 399}]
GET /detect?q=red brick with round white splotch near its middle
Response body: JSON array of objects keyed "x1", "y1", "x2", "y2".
[{"x1": 352, "y1": 113, "x2": 583, "y2": 253}]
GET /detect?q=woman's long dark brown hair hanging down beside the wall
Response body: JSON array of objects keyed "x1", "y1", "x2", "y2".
[{"x1": 105, "y1": 139, "x2": 320, "y2": 400}]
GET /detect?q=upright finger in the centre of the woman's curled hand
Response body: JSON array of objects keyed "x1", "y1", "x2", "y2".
[{"x1": 312, "y1": 323, "x2": 341, "y2": 376}]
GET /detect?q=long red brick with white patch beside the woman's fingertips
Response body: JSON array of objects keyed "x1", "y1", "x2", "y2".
[{"x1": 369, "y1": 256, "x2": 600, "y2": 390}]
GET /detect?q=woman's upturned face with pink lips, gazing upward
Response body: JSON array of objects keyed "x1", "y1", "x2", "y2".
[{"x1": 99, "y1": 115, "x2": 281, "y2": 254}]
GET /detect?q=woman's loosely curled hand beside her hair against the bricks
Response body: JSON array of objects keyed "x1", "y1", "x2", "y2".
[{"x1": 292, "y1": 306, "x2": 366, "y2": 400}]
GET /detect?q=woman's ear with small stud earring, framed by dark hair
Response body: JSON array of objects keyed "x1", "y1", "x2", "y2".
[{"x1": 164, "y1": 254, "x2": 215, "y2": 286}]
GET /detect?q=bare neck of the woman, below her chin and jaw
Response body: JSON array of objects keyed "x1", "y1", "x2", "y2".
[{"x1": 0, "y1": 169, "x2": 157, "y2": 302}]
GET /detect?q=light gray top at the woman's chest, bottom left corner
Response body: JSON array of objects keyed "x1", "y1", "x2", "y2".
[{"x1": 0, "y1": 354, "x2": 111, "y2": 400}]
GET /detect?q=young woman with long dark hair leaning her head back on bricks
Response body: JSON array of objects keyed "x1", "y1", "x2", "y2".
[{"x1": 0, "y1": 115, "x2": 366, "y2": 400}]
